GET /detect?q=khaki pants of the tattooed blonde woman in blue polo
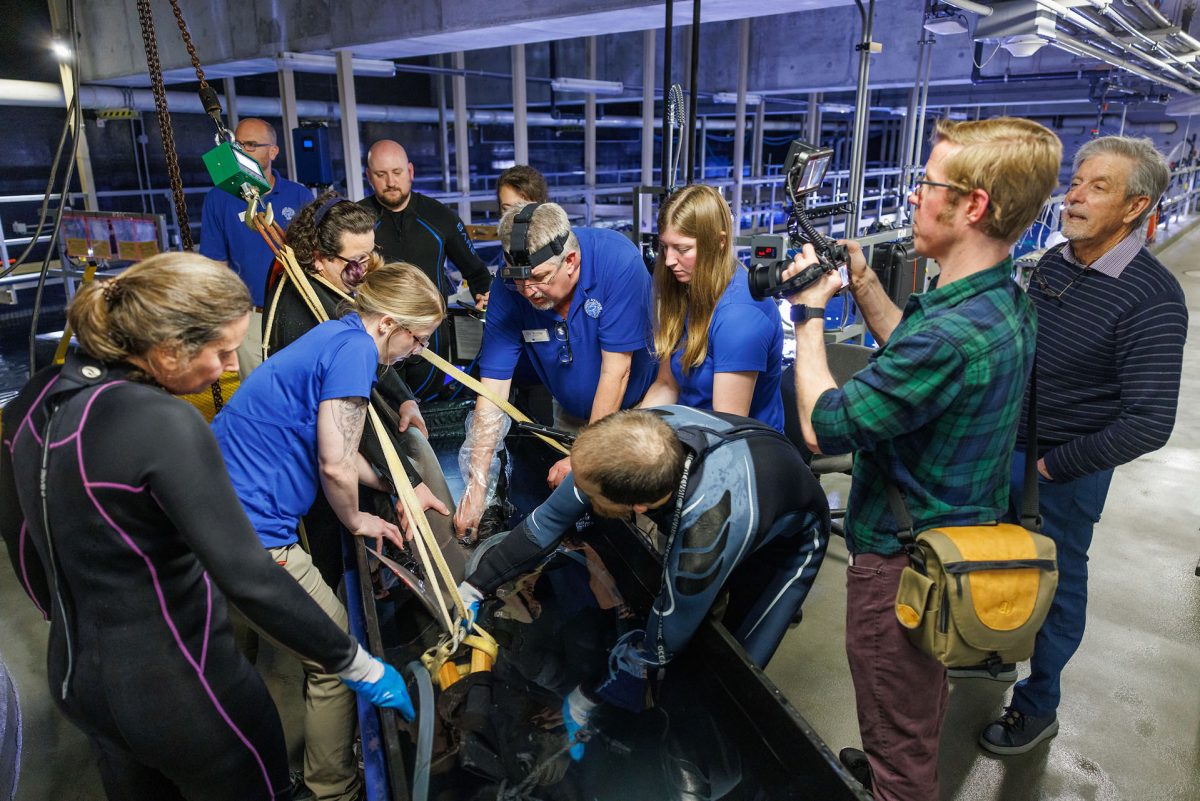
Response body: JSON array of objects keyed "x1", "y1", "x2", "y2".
[{"x1": 268, "y1": 544, "x2": 359, "y2": 801}]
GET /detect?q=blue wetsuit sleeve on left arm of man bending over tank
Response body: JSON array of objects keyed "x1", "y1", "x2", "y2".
[{"x1": 467, "y1": 474, "x2": 592, "y2": 595}]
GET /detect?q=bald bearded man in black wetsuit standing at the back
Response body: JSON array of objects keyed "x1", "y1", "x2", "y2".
[{"x1": 359, "y1": 139, "x2": 492, "y2": 399}]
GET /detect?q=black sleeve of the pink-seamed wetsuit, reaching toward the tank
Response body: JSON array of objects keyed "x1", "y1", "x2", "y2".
[{"x1": 144, "y1": 397, "x2": 356, "y2": 673}]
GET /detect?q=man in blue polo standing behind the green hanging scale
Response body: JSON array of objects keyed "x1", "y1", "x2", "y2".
[{"x1": 200, "y1": 118, "x2": 312, "y2": 378}]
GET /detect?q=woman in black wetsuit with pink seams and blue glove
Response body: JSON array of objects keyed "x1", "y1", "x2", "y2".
[{"x1": 0, "y1": 253, "x2": 412, "y2": 801}]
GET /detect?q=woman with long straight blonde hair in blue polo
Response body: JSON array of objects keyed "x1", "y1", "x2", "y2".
[{"x1": 641, "y1": 183, "x2": 784, "y2": 430}]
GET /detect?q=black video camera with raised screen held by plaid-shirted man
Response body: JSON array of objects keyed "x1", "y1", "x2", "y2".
[{"x1": 750, "y1": 139, "x2": 850, "y2": 300}]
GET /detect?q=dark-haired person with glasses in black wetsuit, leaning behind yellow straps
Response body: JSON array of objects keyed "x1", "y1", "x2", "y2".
[{"x1": 263, "y1": 192, "x2": 466, "y2": 586}]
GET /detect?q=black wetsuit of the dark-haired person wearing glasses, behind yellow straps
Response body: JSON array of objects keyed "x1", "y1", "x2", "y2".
[{"x1": 263, "y1": 275, "x2": 421, "y2": 588}]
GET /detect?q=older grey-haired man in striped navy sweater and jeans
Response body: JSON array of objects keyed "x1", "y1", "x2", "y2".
[{"x1": 974, "y1": 137, "x2": 1188, "y2": 754}]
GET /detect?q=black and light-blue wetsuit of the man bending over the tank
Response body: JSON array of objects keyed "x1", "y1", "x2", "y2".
[{"x1": 467, "y1": 405, "x2": 829, "y2": 667}]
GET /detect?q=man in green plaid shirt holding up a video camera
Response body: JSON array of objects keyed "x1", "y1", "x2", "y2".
[{"x1": 784, "y1": 118, "x2": 1062, "y2": 801}]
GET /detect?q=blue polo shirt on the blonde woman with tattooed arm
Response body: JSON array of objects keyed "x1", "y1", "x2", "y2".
[{"x1": 212, "y1": 314, "x2": 379, "y2": 548}]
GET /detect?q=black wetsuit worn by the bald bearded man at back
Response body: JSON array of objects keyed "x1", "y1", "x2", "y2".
[{"x1": 359, "y1": 192, "x2": 492, "y2": 399}]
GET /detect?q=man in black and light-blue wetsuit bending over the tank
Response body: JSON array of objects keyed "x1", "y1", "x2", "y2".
[{"x1": 460, "y1": 405, "x2": 829, "y2": 759}]
